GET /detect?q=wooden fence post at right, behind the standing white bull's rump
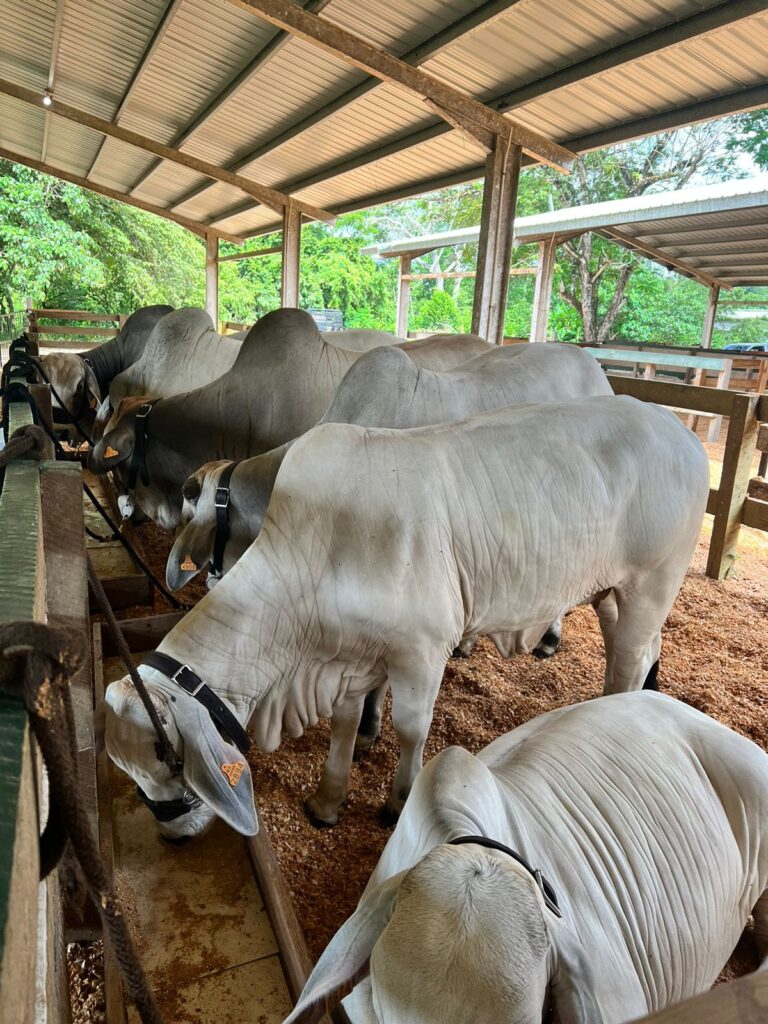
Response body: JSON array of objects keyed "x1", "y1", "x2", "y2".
[{"x1": 707, "y1": 393, "x2": 758, "y2": 580}]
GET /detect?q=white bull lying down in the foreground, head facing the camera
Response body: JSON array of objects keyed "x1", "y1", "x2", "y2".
[{"x1": 286, "y1": 692, "x2": 768, "y2": 1024}]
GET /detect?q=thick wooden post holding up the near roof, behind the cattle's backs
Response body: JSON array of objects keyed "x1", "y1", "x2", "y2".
[{"x1": 472, "y1": 135, "x2": 521, "y2": 345}]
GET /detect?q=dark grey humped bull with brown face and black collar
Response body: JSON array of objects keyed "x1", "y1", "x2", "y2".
[{"x1": 89, "y1": 309, "x2": 490, "y2": 529}]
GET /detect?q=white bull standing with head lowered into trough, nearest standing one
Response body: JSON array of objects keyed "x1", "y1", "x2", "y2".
[{"x1": 100, "y1": 397, "x2": 709, "y2": 836}]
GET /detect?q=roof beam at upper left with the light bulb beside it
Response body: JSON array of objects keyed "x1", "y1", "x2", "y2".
[{"x1": 0, "y1": 79, "x2": 334, "y2": 221}]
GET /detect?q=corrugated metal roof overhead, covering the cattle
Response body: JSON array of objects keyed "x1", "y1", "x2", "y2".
[{"x1": 0, "y1": 0, "x2": 768, "y2": 236}]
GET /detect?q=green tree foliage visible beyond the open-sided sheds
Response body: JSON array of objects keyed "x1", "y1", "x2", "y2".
[{"x1": 0, "y1": 112, "x2": 768, "y2": 344}]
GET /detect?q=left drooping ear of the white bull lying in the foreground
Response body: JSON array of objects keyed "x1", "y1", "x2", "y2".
[{"x1": 284, "y1": 871, "x2": 408, "y2": 1024}]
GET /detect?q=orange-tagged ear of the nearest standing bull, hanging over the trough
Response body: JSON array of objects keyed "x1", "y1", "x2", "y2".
[{"x1": 179, "y1": 700, "x2": 259, "y2": 836}]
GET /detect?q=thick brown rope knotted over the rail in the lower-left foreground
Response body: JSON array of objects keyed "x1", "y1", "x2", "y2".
[{"x1": 0, "y1": 426, "x2": 163, "y2": 1024}]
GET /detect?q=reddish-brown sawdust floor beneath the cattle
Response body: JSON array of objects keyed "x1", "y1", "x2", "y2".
[{"x1": 121, "y1": 421, "x2": 768, "y2": 977}]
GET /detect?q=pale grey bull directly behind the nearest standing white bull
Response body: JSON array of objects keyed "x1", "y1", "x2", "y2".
[{"x1": 166, "y1": 344, "x2": 613, "y2": 590}]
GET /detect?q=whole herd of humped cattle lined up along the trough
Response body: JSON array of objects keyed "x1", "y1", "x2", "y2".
[{"x1": 45, "y1": 306, "x2": 768, "y2": 1024}]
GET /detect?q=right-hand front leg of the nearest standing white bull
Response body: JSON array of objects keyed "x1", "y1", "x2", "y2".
[{"x1": 382, "y1": 664, "x2": 445, "y2": 824}]
